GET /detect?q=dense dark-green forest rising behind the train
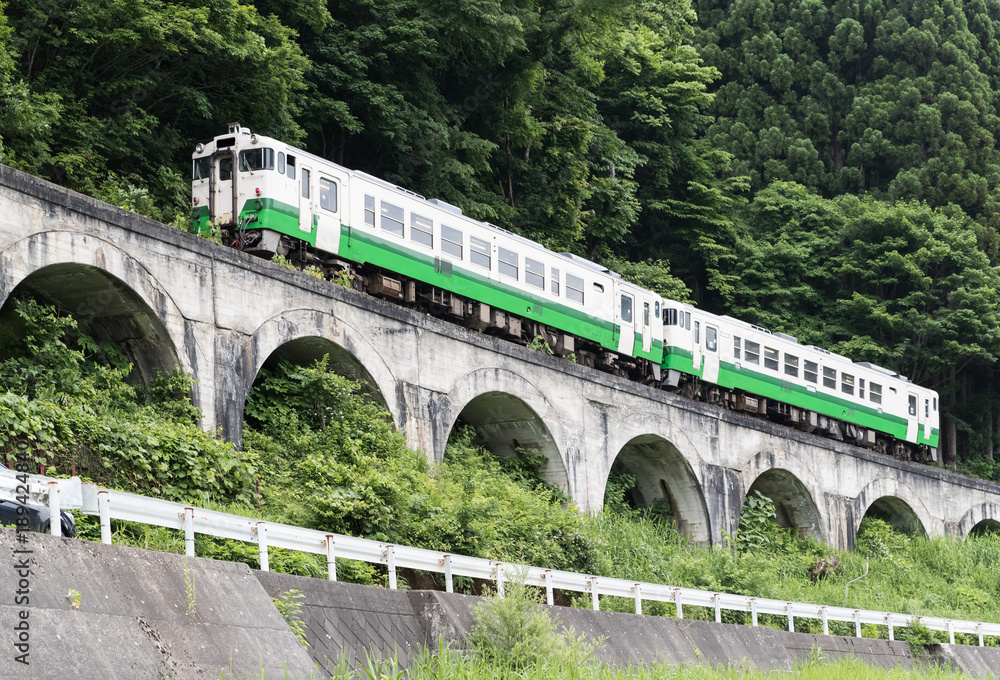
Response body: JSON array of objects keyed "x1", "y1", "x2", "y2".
[{"x1": 0, "y1": 0, "x2": 1000, "y2": 474}]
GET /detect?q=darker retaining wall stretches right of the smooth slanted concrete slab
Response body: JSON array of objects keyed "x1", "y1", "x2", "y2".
[{"x1": 256, "y1": 572, "x2": 913, "y2": 670}]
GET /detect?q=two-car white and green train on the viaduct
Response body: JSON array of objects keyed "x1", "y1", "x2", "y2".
[{"x1": 192, "y1": 123, "x2": 940, "y2": 461}]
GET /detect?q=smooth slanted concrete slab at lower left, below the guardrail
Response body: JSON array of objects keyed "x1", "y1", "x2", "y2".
[{"x1": 0, "y1": 529, "x2": 318, "y2": 680}]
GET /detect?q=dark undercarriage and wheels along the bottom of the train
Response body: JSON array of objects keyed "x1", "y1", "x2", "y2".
[{"x1": 223, "y1": 228, "x2": 937, "y2": 463}]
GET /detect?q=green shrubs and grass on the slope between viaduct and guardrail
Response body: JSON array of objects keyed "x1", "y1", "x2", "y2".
[{"x1": 0, "y1": 300, "x2": 1000, "y2": 656}]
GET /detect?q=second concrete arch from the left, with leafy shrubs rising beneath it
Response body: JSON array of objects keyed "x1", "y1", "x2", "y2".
[{"x1": 231, "y1": 309, "x2": 406, "y2": 443}]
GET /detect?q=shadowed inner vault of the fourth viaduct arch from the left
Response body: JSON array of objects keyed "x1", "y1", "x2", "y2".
[{"x1": 605, "y1": 434, "x2": 712, "y2": 544}]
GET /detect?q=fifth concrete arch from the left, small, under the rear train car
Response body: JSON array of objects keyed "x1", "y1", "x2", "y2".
[{"x1": 737, "y1": 449, "x2": 830, "y2": 541}]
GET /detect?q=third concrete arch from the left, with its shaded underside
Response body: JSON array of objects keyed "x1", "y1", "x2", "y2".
[{"x1": 442, "y1": 368, "x2": 573, "y2": 495}]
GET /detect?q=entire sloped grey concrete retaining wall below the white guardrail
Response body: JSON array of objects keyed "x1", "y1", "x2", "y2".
[{"x1": 0, "y1": 529, "x2": 1000, "y2": 680}]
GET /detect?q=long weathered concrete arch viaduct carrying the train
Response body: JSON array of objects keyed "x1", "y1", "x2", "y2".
[{"x1": 0, "y1": 166, "x2": 1000, "y2": 548}]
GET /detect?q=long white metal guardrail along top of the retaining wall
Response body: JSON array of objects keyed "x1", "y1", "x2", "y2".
[{"x1": 0, "y1": 469, "x2": 1000, "y2": 647}]
